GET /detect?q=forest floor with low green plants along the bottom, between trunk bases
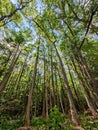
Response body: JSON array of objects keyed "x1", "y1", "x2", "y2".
[{"x1": 0, "y1": 114, "x2": 98, "y2": 130}]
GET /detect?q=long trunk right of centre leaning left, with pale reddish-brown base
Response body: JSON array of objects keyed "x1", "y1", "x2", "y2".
[{"x1": 53, "y1": 43, "x2": 79, "y2": 126}]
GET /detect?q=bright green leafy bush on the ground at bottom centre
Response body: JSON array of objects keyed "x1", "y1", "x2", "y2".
[{"x1": 31, "y1": 106, "x2": 68, "y2": 130}]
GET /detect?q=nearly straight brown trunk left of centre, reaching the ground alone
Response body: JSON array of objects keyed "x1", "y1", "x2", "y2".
[{"x1": 25, "y1": 45, "x2": 39, "y2": 127}]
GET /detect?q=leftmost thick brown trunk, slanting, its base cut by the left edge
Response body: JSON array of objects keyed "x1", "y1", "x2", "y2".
[{"x1": 0, "y1": 46, "x2": 21, "y2": 94}]
